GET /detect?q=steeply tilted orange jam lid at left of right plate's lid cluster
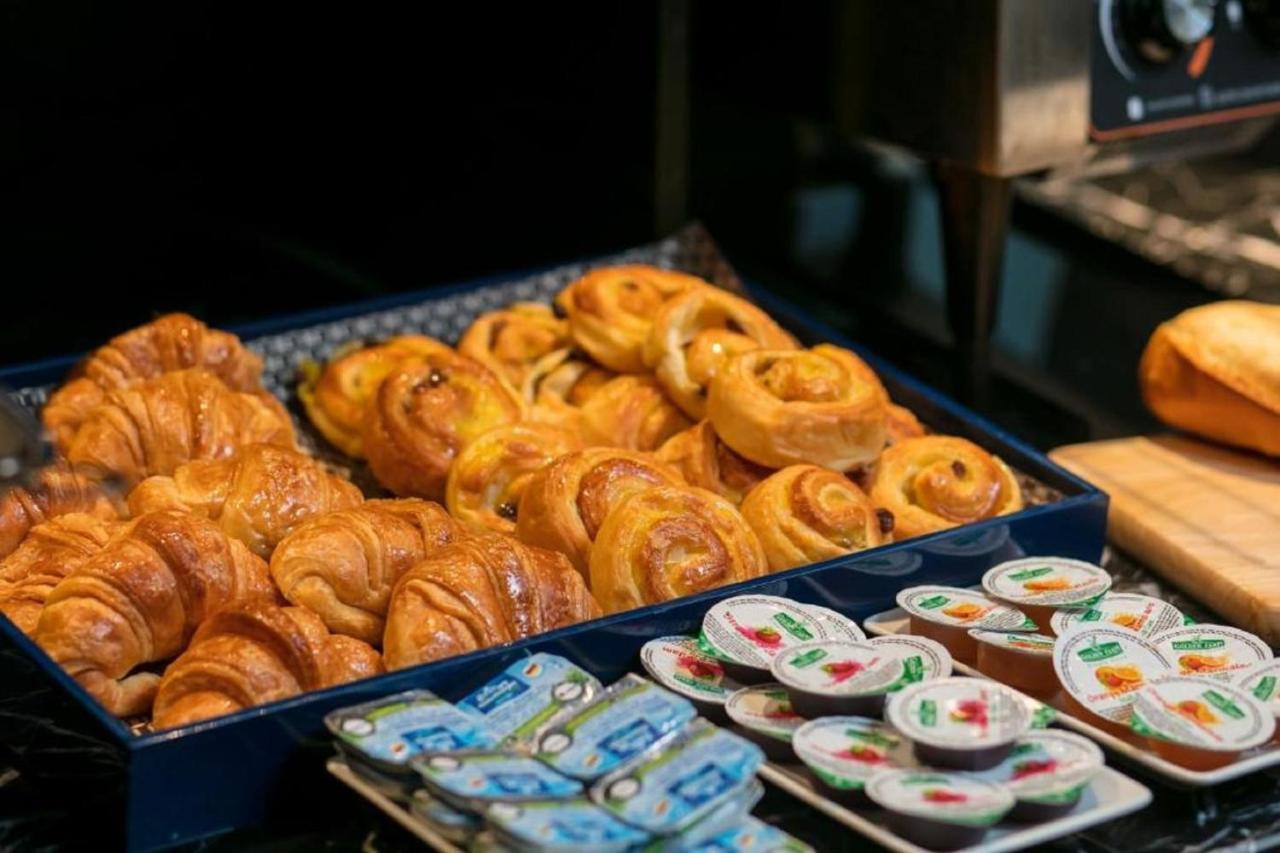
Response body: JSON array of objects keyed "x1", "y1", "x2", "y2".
[{"x1": 1053, "y1": 624, "x2": 1172, "y2": 722}]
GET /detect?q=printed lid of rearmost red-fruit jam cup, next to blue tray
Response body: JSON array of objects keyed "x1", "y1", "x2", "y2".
[{"x1": 703, "y1": 596, "x2": 828, "y2": 670}]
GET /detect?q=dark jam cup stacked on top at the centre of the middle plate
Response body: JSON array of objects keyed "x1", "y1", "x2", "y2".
[{"x1": 884, "y1": 678, "x2": 1032, "y2": 770}]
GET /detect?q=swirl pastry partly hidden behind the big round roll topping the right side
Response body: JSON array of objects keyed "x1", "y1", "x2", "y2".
[{"x1": 644, "y1": 287, "x2": 797, "y2": 419}]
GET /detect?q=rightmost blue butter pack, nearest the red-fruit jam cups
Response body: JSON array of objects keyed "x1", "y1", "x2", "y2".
[{"x1": 591, "y1": 720, "x2": 764, "y2": 835}]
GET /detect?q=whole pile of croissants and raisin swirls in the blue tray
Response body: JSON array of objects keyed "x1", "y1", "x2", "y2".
[{"x1": 0, "y1": 265, "x2": 1023, "y2": 727}]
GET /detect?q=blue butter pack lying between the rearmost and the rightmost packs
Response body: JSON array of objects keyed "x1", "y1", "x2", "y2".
[{"x1": 535, "y1": 675, "x2": 698, "y2": 780}]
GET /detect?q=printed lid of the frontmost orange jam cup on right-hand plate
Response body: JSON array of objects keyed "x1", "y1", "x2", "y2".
[{"x1": 1129, "y1": 675, "x2": 1276, "y2": 752}]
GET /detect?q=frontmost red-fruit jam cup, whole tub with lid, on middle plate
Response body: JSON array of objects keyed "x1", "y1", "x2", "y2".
[{"x1": 867, "y1": 770, "x2": 1014, "y2": 850}]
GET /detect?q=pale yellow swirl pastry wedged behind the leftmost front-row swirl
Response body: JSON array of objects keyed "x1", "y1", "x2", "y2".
[{"x1": 444, "y1": 423, "x2": 582, "y2": 533}]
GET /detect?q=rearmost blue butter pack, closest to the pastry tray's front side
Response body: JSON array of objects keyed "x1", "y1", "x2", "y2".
[{"x1": 458, "y1": 652, "x2": 602, "y2": 744}]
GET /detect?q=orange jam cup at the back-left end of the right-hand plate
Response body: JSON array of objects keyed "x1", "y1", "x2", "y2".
[{"x1": 897, "y1": 587, "x2": 1036, "y2": 663}]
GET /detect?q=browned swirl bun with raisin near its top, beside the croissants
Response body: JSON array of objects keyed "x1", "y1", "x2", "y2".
[{"x1": 364, "y1": 352, "x2": 524, "y2": 500}]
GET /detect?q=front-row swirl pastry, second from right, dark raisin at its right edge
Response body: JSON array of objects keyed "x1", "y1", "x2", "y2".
[{"x1": 742, "y1": 465, "x2": 893, "y2": 571}]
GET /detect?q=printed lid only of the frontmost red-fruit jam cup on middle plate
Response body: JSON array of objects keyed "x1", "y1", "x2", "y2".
[{"x1": 865, "y1": 770, "x2": 1014, "y2": 826}]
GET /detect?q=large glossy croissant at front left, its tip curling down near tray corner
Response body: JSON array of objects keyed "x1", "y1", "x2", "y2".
[{"x1": 35, "y1": 511, "x2": 275, "y2": 716}]
